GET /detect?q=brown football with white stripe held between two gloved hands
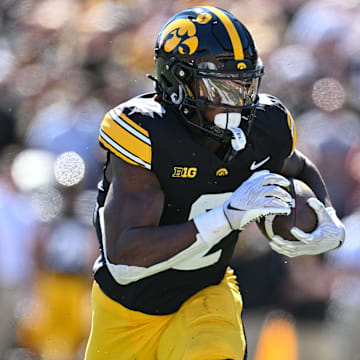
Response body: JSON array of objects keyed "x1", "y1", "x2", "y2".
[{"x1": 257, "y1": 178, "x2": 317, "y2": 241}]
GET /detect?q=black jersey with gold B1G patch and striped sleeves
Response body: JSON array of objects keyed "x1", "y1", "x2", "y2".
[{"x1": 95, "y1": 94, "x2": 296, "y2": 314}]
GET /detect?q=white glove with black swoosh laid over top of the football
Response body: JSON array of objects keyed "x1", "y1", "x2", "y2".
[{"x1": 223, "y1": 170, "x2": 295, "y2": 230}]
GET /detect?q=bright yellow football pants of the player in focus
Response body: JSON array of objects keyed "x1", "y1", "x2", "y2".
[{"x1": 85, "y1": 269, "x2": 246, "y2": 360}]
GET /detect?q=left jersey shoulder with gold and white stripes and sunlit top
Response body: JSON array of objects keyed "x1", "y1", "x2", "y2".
[{"x1": 99, "y1": 95, "x2": 165, "y2": 170}]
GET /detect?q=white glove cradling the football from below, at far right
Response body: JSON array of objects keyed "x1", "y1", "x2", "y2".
[{"x1": 269, "y1": 198, "x2": 345, "y2": 257}]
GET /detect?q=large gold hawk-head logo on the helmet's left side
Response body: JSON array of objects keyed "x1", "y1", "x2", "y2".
[{"x1": 159, "y1": 19, "x2": 199, "y2": 55}]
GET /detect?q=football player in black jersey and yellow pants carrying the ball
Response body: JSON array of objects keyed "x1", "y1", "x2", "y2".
[{"x1": 86, "y1": 6, "x2": 344, "y2": 360}]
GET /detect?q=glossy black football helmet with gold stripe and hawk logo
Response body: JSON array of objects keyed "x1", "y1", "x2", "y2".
[{"x1": 155, "y1": 6, "x2": 264, "y2": 142}]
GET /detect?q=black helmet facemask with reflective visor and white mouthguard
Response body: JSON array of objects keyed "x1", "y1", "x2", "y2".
[{"x1": 167, "y1": 62, "x2": 263, "y2": 151}]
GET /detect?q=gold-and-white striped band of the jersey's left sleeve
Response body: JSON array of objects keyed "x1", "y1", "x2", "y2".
[{"x1": 99, "y1": 108, "x2": 152, "y2": 170}]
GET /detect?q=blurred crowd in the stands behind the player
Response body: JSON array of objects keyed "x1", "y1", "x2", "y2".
[{"x1": 0, "y1": 0, "x2": 360, "y2": 360}]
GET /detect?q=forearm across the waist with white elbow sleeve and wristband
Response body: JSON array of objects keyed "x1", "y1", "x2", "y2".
[{"x1": 99, "y1": 206, "x2": 231, "y2": 285}]
